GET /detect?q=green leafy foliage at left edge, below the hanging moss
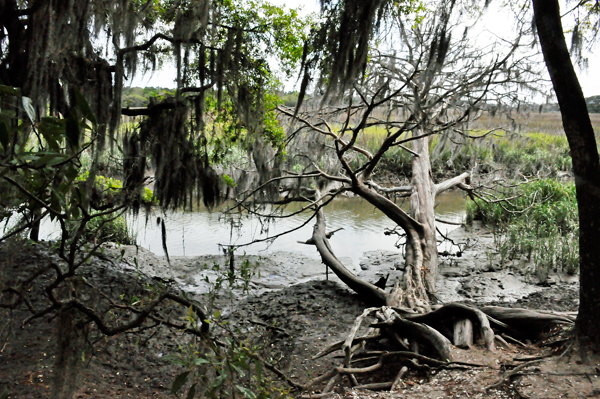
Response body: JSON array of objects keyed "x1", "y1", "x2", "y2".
[{"x1": 0, "y1": 87, "x2": 145, "y2": 258}]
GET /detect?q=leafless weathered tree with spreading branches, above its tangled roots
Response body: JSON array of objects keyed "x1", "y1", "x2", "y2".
[{"x1": 240, "y1": 2, "x2": 536, "y2": 311}]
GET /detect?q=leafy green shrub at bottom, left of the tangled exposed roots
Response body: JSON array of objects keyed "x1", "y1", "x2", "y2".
[{"x1": 169, "y1": 256, "x2": 291, "y2": 399}]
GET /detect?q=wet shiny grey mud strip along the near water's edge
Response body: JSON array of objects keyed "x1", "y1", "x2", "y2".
[{"x1": 107, "y1": 223, "x2": 578, "y2": 303}]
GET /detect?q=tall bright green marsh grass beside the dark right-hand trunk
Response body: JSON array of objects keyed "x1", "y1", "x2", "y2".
[{"x1": 467, "y1": 179, "x2": 579, "y2": 281}]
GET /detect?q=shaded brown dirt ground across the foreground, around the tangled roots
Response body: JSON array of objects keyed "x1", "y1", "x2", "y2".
[{"x1": 0, "y1": 238, "x2": 600, "y2": 399}]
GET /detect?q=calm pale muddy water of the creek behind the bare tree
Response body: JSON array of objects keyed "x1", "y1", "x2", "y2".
[{"x1": 129, "y1": 192, "x2": 465, "y2": 266}]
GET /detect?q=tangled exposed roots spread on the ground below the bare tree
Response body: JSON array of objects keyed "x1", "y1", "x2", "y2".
[{"x1": 305, "y1": 304, "x2": 572, "y2": 397}]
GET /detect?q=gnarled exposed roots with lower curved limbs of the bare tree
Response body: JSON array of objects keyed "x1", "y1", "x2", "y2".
[{"x1": 290, "y1": 191, "x2": 575, "y2": 398}]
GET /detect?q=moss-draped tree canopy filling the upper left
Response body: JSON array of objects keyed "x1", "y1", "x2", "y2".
[{"x1": 0, "y1": 0, "x2": 308, "y2": 211}]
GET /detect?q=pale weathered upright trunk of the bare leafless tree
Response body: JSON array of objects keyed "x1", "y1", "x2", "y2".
[{"x1": 410, "y1": 130, "x2": 438, "y2": 292}]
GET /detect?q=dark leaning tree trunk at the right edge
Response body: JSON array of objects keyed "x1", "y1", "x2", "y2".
[{"x1": 533, "y1": 0, "x2": 600, "y2": 353}]
